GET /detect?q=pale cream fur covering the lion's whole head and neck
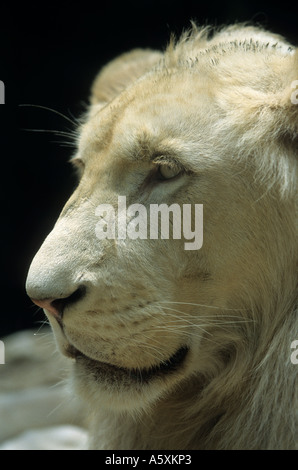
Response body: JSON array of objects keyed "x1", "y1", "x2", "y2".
[{"x1": 27, "y1": 25, "x2": 298, "y2": 449}]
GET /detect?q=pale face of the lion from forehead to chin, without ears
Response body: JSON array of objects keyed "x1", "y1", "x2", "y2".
[{"x1": 27, "y1": 27, "x2": 298, "y2": 409}]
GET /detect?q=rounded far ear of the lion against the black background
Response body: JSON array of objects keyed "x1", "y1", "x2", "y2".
[{"x1": 90, "y1": 49, "x2": 162, "y2": 105}]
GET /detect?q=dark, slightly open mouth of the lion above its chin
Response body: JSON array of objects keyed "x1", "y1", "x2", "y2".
[{"x1": 69, "y1": 346, "x2": 189, "y2": 384}]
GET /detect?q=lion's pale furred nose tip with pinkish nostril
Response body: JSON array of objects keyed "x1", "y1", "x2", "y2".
[{"x1": 26, "y1": 218, "x2": 93, "y2": 319}]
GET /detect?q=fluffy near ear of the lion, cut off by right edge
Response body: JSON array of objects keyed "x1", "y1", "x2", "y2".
[{"x1": 228, "y1": 49, "x2": 298, "y2": 146}]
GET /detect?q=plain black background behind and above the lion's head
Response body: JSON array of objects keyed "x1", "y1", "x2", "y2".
[{"x1": 0, "y1": 0, "x2": 298, "y2": 337}]
